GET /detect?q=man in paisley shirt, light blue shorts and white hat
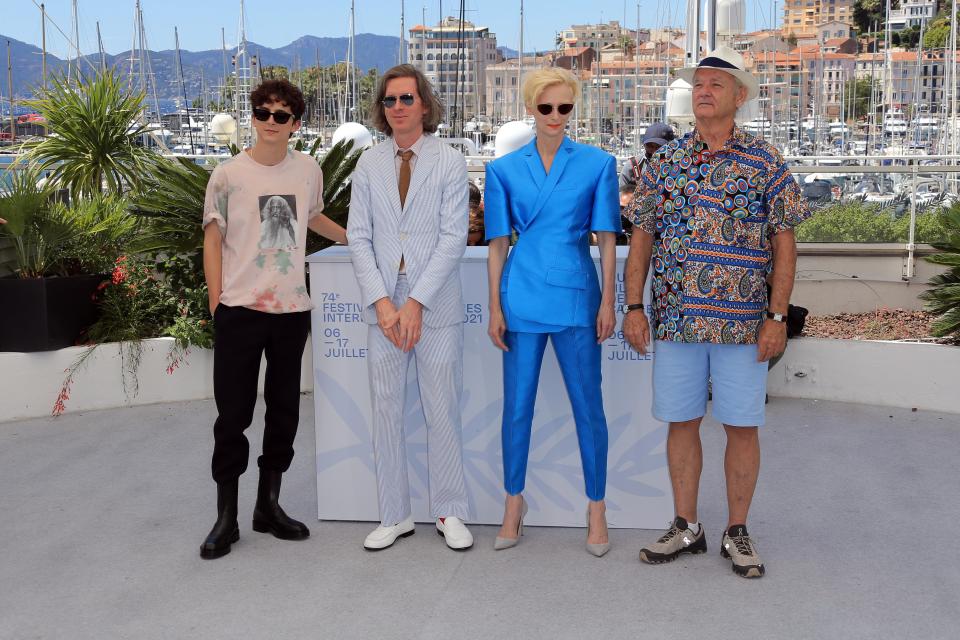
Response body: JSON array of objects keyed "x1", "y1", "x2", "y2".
[{"x1": 623, "y1": 46, "x2": 810, "y2": 578}]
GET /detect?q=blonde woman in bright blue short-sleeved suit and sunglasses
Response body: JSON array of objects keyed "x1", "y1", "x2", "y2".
[{"x1": 484, "y1": 67, "x2": 621, "y2": 556}]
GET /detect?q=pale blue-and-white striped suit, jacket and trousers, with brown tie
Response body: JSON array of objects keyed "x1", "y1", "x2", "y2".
[{"x1": 347, "y1": 134, "x2": 469, "y2": 526}]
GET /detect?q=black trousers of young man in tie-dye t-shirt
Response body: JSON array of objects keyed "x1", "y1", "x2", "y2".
[{"x1": 212, "y1": 304, "x2": 310, "y2": 482}]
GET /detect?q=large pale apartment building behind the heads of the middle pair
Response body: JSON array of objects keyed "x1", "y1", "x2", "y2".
[{"x1": 407, "y1": 18, "x2": 503, "y2": 118}]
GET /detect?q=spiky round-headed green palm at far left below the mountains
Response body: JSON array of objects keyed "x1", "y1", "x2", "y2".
[{"x1": 24, "y1": 70, "x2": 159, "y2": 197}]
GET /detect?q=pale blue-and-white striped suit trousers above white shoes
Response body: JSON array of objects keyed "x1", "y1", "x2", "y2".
[{"x1": 367, "y1": 274, "x2": 469, "y2": 526}]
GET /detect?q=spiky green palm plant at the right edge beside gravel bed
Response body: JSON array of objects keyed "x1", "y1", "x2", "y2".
[{"x1": 920, "y1": 205, "x2": 960, "y2": 341}]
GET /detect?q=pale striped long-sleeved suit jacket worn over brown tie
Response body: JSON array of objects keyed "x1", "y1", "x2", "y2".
[{"x1": 347, "y1": 134, "x2": 469, "y2": 327}]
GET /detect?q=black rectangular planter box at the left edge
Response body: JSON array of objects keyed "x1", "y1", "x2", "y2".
[{"x1": 0, "y1": 275, "x2": 110, "y2": 351}]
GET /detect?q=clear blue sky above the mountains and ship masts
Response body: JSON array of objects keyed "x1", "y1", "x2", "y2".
[{"x1": 0, "y1": 0, "x2": 783, "y2": 57}]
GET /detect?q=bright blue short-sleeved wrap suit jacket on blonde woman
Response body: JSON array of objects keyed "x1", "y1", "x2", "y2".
[{"x1": 484, "y1": 138, "x2": 622, "y2": 328}]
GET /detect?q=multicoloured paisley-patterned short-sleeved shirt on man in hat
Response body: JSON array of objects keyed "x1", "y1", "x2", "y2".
[{"x1": 624, "y1": 127, "x2": 810, "y2": 344}]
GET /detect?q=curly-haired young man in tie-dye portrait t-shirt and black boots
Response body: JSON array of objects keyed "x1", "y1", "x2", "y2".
[{"x1": 200, "y1": 80, "x2": 347, "y2": 559}]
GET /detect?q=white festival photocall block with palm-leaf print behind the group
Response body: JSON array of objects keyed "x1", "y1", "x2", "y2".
[{"x1": 307, "y1": 247, "x2": 673, "y2": 529}]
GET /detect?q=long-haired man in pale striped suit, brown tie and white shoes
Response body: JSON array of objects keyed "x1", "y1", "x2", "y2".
[{"x1": 347, "y1": 65, "x2": 473, "y2": 551}]
